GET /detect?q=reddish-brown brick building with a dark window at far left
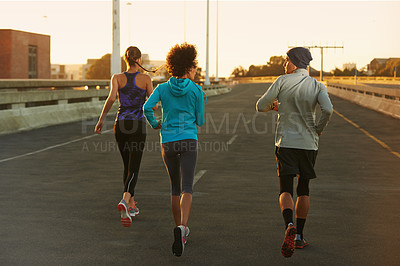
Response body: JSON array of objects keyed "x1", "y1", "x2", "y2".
[{"x1": 0, "y1": 29, "x2": 51, "y2": 79}]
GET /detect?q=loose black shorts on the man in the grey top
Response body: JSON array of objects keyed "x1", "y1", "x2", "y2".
[{"x1": 275, "y1": 147, "x2": 318, "y2": 179}]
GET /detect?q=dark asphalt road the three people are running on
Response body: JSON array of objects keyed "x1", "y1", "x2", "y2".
[{"x1": 0, "y1": 84, "x2": 400, "y2": 265}]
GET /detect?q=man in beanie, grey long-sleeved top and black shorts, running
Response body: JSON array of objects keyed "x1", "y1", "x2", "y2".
[{"x1": 256, "y1": 47, "x2": 333, "y2": 257}]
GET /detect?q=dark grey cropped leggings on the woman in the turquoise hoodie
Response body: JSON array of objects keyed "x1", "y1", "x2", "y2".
[{"x1": 161, "y1": 139, "x2": 197, "y2": 196}]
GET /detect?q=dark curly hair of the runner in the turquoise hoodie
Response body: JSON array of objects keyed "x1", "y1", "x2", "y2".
[{"x1": 167, "y1": 42, "x2": 197, "y2": 77}]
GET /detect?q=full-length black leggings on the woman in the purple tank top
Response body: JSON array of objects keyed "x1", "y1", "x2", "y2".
[{"x1": 114, "y1": 120, "x2": 146, "y2": 196}]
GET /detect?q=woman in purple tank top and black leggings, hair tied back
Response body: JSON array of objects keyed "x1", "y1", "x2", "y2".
[{"x1": 95, "y1": 46, "x2": 154, "y2": 227}]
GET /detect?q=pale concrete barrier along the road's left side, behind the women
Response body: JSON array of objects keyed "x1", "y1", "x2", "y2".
[{"x1": 0, "y1": 81, "x2": 231, "y2": 135}]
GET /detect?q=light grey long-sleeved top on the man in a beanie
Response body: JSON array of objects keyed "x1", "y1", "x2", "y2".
[{"x1": 256, "y1": 68, "x2": 333, "y2": 150}]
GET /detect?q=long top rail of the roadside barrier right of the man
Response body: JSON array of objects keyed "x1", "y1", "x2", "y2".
[{"x1": 327, "y1": 81, "x2": 400, "y2": 101}]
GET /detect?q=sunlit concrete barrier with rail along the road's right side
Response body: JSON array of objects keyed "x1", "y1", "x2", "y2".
[{"x1": 326, "y1": 82, "x2": 400, "y2": 119}]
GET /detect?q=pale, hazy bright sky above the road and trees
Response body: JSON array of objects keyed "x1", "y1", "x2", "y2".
[{"x1": 0, "y1": 0, "x2": 400, "y2": 77}]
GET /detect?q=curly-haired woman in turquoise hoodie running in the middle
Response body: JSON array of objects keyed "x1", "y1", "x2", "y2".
[{"x1": 143, "y1": 43, "x2": 204, "y2": 257}]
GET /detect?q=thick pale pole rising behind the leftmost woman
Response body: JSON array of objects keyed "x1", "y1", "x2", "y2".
[{"x1": 111, "y1": 0, "x2": 121, "y2": 76}]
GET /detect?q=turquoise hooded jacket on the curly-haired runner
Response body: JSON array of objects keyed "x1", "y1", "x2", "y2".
[{"x1": 143, "y1": 77, "x2": 204, "y2": 143}]
